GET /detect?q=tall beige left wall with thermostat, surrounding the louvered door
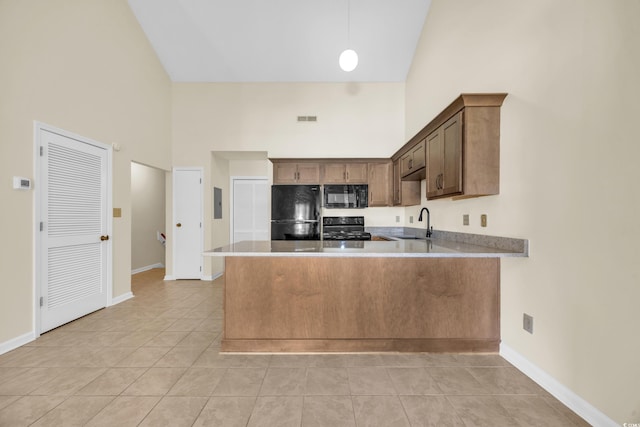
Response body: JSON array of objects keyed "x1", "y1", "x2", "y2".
[{"x1": 0, "y1": 0, "x2": 171, "y2": 343}]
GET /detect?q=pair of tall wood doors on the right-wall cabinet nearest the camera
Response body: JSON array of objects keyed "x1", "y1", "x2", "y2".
[{"x1": 427, "y1": 111, "x2": 463, "y2": 199}]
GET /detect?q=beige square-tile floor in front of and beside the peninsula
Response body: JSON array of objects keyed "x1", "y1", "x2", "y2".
[{"x1": 0, "y1": 270, "x2": 588, "y2": 427}]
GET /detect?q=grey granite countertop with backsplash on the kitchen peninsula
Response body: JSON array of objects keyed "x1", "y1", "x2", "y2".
[{"x1": 203, "y1": 231, "x2": 529, "y2": 258}]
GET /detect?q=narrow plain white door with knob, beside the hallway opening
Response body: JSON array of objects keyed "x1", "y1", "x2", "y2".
[{"x1": 173, "y1": 168, "x2": 203, "y2": 279}]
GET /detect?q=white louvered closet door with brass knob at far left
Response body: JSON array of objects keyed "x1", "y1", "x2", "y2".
[{"x1": 40, "y1": 130, "x2": 110, "y2": 332}]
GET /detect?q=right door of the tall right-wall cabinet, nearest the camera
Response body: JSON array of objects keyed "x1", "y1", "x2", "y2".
[{"x1": 440, "y1": 112, "x2": 463, "y2": 195}]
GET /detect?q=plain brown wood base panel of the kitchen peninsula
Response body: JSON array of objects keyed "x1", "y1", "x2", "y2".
[{"x1": 221, "y1": 256, "x2": 500, "y2": 352}]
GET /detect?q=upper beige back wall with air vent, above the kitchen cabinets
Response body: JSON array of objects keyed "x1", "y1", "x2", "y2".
[{"x1": 173, "y1": 83, "x2": 404, "y2": 166}]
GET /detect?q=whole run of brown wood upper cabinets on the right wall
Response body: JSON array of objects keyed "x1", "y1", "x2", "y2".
[{"x1": 392, "y1": 93, "x2": 507, "y2": 201}]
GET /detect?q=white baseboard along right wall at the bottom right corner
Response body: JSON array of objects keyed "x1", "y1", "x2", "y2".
[{"x1": 500, "y1": 344, "x2": 619, "y2": 427}]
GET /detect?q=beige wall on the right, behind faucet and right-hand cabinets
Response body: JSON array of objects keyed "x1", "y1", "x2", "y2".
[{"x1": 406, "y1": 0, "x2": 640, "y2": 423}]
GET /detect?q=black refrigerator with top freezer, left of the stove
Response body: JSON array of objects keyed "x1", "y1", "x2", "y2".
[{"x1": 271, "y1": 185, "x2": 322, "y2": 240}]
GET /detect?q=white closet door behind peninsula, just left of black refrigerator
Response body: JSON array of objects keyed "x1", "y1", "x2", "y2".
[{"x1": 231, "y1": 178, "x2": 270, "y2": 243}]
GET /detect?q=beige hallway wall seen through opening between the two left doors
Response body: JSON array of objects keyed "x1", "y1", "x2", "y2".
[{"x1": 131, "y1": 163, "x2": 166, "y2": 271}]
